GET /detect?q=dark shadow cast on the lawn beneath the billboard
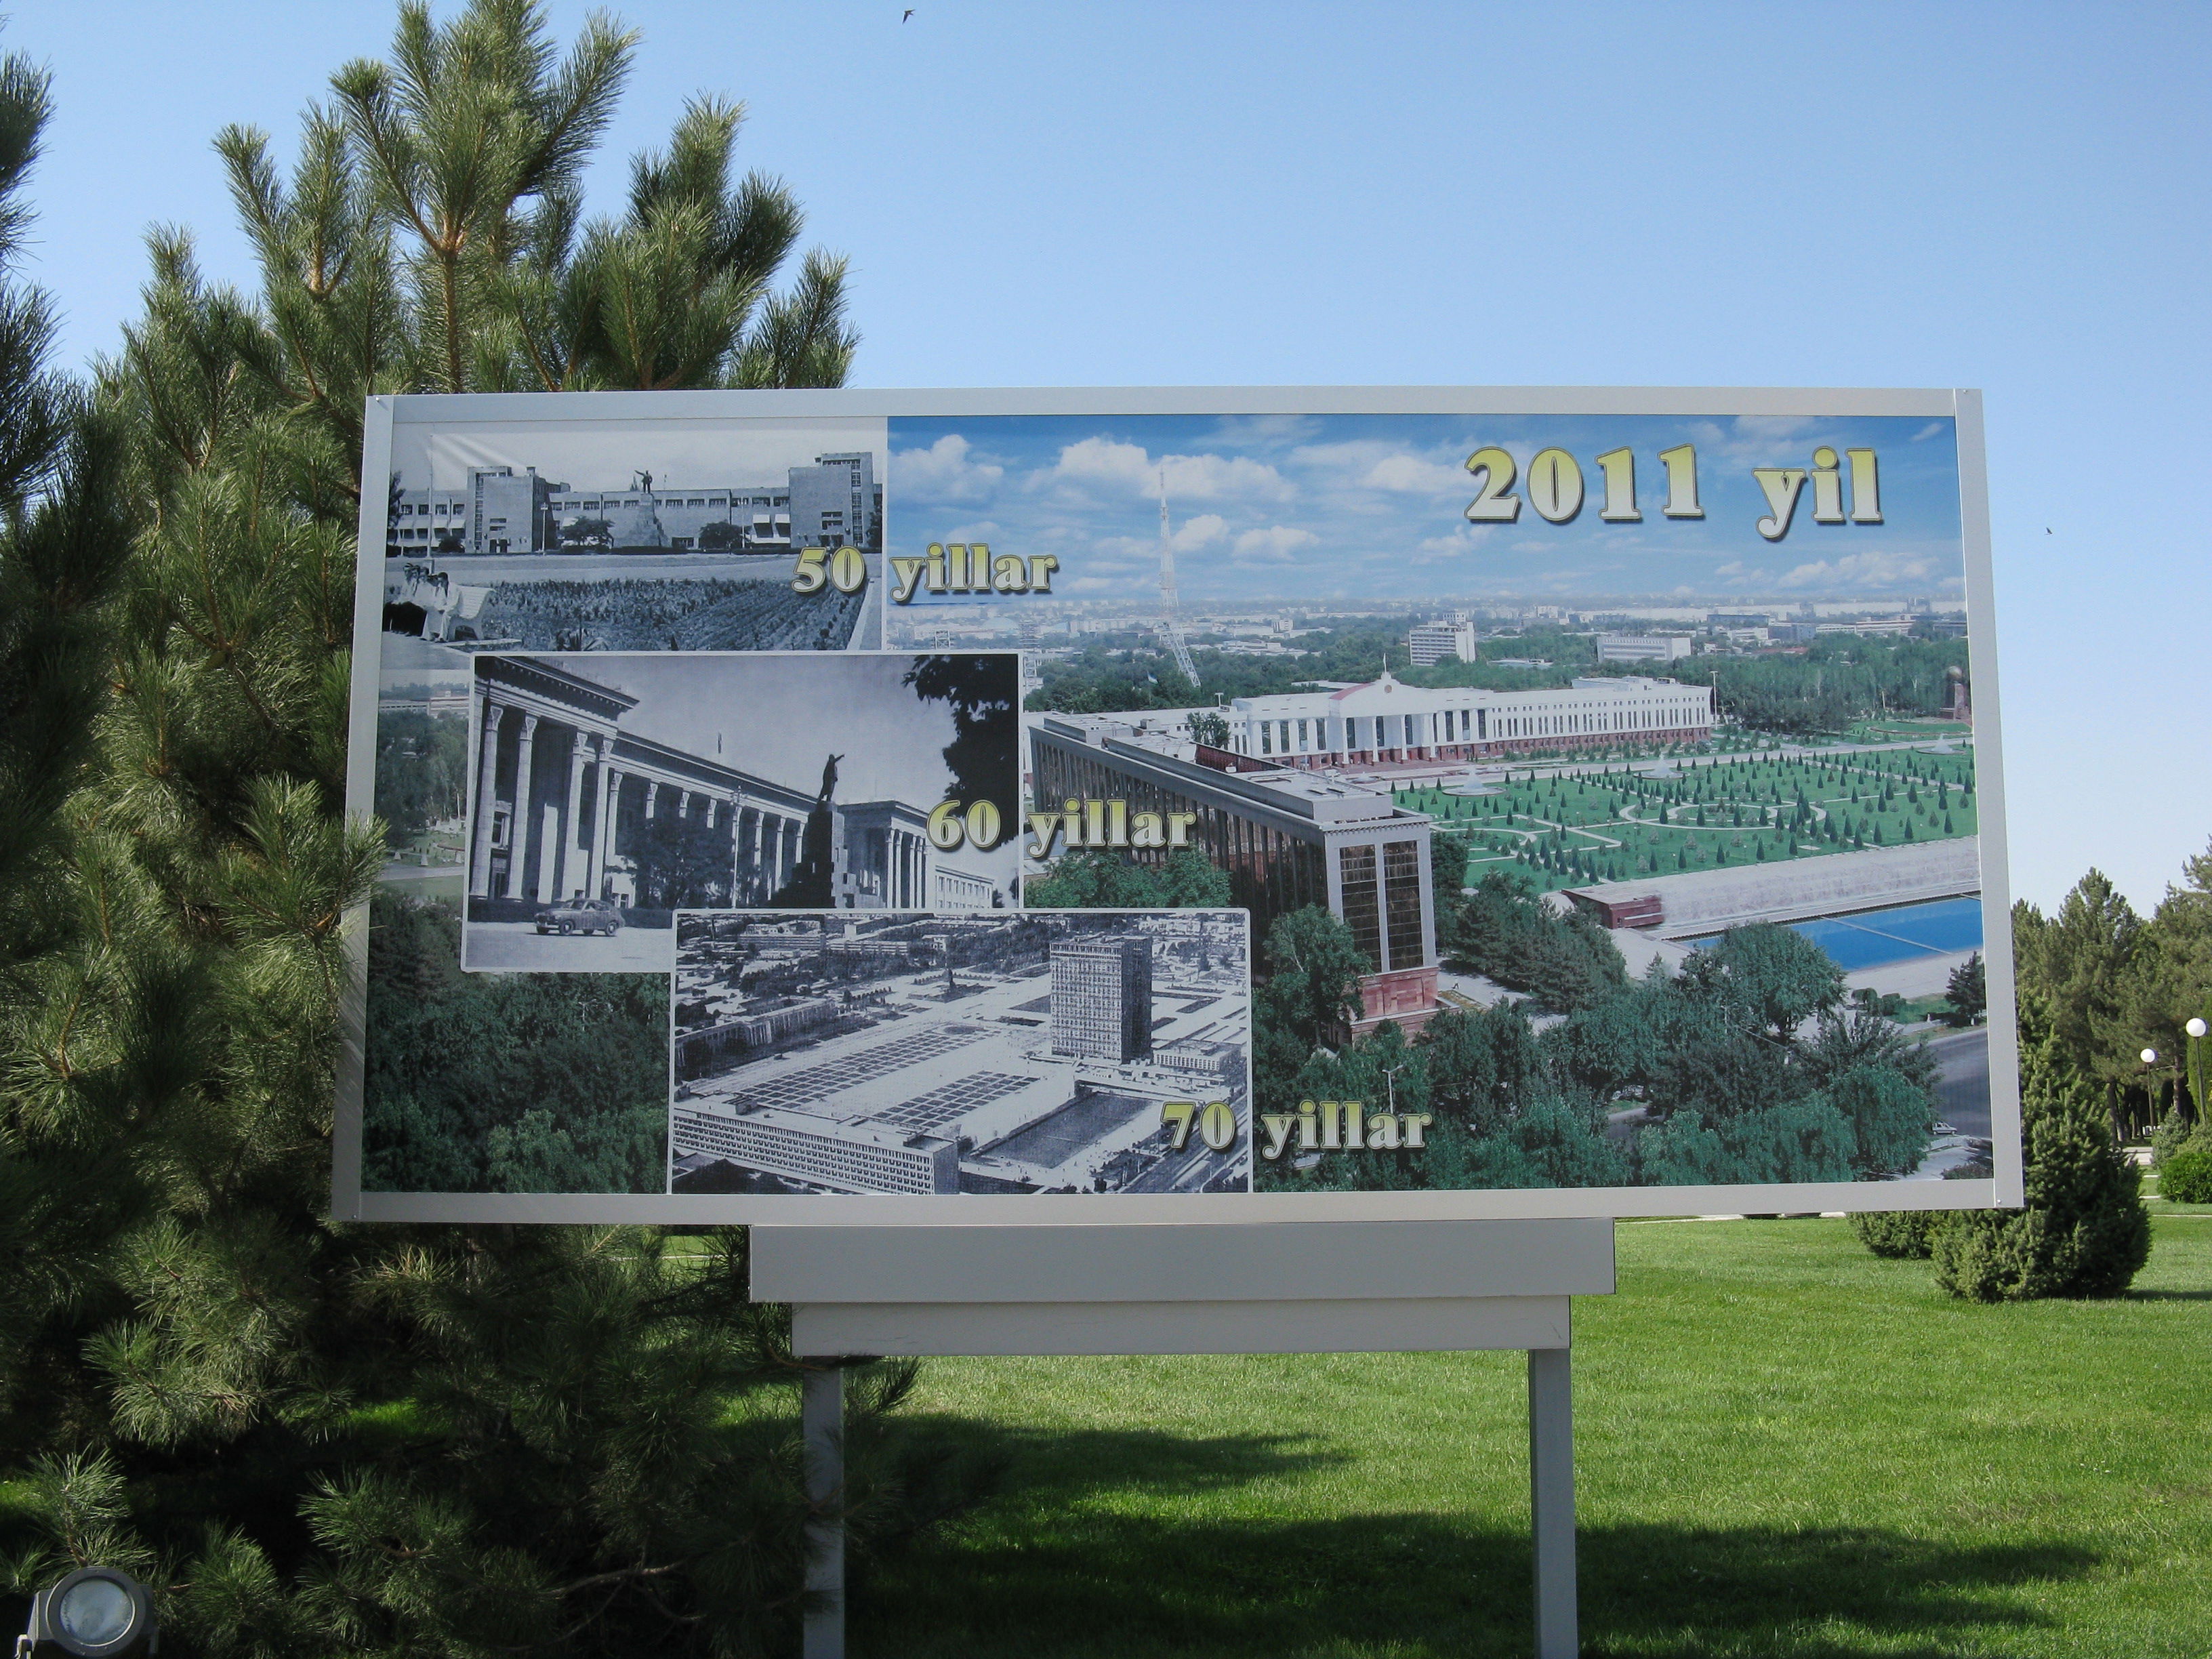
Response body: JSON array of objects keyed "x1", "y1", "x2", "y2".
[{"x1": 849, "y1": 1418, "x2": 2102, "y2": 1659}]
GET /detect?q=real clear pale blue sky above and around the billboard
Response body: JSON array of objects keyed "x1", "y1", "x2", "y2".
[{"x1": 0, "y1": 0, "x2": 2212, "y2": 905}]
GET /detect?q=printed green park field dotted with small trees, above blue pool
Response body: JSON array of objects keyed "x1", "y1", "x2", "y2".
[{"x1": 1396, "y1": 747, "x2": 1978, "y2": 889}]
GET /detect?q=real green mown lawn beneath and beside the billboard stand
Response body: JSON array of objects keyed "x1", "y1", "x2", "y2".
[{"x1": 852, "y1": 1204, "x2": 2212, "y2": 1659}]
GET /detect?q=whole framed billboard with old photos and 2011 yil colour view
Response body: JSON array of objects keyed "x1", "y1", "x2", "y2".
[{"x1": 334, "y1": 389, "x2": 2022, "y2": 1223}]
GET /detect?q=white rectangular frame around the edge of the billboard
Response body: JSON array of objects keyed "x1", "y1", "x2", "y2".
[{"x1": 332, "y1": 387, "x2": 2024, "y2": 1225}]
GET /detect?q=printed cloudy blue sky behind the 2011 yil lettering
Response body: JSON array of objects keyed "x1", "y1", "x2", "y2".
[{"x1": 885, "y1": 413, "x2": 1962, "y2": 604}]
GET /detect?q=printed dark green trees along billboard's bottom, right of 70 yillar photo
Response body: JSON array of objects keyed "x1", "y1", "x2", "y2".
[{"x1": 1254, "y1": 876, "x2": 1936, "y2": 1190}]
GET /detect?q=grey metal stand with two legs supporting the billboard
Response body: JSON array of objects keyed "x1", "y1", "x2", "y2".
[{"x1": 752, "y1": 1218, "x2": 1612, "y2": 1659}]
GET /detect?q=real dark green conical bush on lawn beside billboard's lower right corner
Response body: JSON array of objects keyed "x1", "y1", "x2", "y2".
[{"x1": 1933, "y1": 1036, "x2": 2150, "y2": 1303}]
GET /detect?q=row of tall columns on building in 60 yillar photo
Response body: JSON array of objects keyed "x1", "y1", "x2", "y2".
[{"x1": 469, "y1": 699, "x2": 805, "y2": 905}]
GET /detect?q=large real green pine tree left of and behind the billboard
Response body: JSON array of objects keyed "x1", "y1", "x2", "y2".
[{"x1": 0, "y1": 0, "x2": 969, "y2": 1654}]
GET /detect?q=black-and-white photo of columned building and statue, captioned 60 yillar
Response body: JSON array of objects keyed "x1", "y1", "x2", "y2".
[{"x1": 462, "y1": 653, "x2": 1020, "y2": 973}]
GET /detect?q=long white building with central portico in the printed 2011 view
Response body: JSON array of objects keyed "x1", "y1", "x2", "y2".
[{"x1": 1223, "y1": 672, "x2": 1712, "y2": 768}]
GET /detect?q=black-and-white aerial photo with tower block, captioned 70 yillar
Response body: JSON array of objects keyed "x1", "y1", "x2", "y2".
[{"x1": 668, "y1": 909, "x2": 1252, "y2": 1195}]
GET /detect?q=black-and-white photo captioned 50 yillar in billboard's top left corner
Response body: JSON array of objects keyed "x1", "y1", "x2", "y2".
[{"x1": 383, "y1": 420, "x2": 885, "y2": 653}]
